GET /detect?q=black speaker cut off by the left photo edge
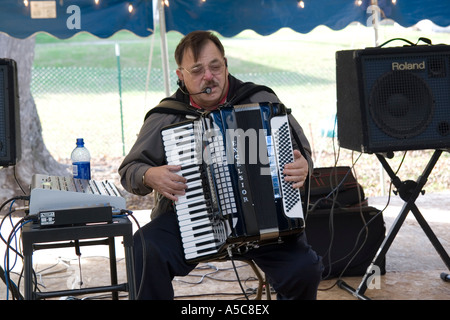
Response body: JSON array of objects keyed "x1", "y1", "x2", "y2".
[{"x1": 0, "y1": 59, "x2": 20, "y2": 167}]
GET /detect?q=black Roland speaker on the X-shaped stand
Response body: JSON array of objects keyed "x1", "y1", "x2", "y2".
[{"x1": 336, "y1": 45, "x2": 450, "y2": 153}]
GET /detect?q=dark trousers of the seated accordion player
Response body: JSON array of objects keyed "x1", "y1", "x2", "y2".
[{"x1": 134, "y1": 212, "x2": 323, "y2": 300}]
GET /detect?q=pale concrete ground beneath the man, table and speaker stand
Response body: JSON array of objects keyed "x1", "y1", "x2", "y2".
[{"x1": 0, "y1": 193, "x2": 450, "y2": 300}]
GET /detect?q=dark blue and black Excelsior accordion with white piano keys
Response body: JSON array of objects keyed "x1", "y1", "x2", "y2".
[{"x1": 161, "y1": 103, "x2": 305, "y2": 262}]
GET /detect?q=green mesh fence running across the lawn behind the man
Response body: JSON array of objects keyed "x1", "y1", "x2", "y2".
[{"x1": 31, "y1": 66, "x2": 335, "y2": 159}]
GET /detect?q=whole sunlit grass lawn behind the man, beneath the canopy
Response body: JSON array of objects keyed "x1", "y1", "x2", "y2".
[{"x1": 32, "y1": 25, "x2": 450, "y2": 195}]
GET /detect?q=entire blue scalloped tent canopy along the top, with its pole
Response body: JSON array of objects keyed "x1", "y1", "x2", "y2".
[{"x1": 0, "y1": 0, "x2": 450, "y2": 95}]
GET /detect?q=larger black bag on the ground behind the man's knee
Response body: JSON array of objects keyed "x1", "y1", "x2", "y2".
[{"x1": 305, "y1": 206, "x2": 386, "y2": 279}]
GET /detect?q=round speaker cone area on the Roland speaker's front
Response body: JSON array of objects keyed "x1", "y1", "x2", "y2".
[{"x1": 369, "y1": 71, "x2": 434, "y2": 139}]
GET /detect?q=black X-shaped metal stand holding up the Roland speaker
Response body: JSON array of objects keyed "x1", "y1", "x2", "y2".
[{"x1": 338, "y1": 150, "x2": 450, "y2": 300}]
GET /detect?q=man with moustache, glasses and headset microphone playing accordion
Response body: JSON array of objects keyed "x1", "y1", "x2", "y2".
[{"x1": 119, "y1": 31, "x2": 323, "y2": 300}]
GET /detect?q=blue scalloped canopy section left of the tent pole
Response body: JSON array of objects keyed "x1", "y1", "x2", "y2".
[{"x1": 0, "y1": 0, "x2": 153, "y2": 39}]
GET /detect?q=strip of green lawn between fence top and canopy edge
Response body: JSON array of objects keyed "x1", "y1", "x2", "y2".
[{"x1": 35, "y1": 25, "x2": 450, "y2": 73}]
